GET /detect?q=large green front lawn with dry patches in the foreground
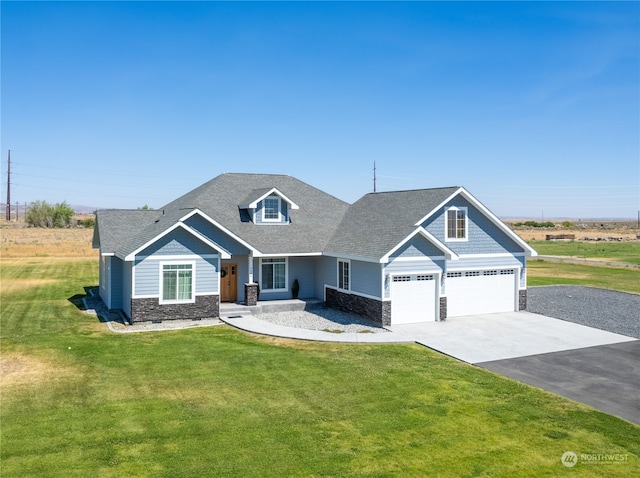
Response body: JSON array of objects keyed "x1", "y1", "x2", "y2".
[{"x1": 0, "y1": 258, "x2": 640, "y2": 478}]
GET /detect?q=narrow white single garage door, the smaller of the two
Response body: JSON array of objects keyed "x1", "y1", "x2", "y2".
[{"x1": 391, "y1": 274, "x2": 437, "y2": 325}]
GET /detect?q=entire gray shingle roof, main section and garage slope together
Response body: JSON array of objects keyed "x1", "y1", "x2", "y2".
[{"x1": 94, "y1": 173, "x2": 458, "y2": 259}]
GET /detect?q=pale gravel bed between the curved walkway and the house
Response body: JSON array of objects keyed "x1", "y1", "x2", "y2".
[{"x1": 256, "y1": 306, "x2": 387, "y2": 333}]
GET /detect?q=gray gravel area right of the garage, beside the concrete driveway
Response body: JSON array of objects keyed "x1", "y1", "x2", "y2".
[{"x1": 527, "y1": 285, "x2": 640, "y2": 339}]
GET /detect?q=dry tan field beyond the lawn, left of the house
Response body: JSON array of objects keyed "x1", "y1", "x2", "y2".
[{"x1": 0, "y1": 226, "x2": 98, "y2": 258}]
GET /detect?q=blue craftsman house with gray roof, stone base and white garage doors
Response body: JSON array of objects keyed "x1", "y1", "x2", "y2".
[{"x1": 93, "y1": 174, "x2": 536, "y2": 325}]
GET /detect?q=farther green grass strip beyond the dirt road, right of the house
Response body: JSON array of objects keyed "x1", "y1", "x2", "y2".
[{"x1": 529, "y1": 241, "x2": 640, "y2": 264}]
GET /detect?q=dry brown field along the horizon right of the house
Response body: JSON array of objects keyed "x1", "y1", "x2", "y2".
[{"x1": 505, "y1": 219, "x2": 640, "y2": 241}]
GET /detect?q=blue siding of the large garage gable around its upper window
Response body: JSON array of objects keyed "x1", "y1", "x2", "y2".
[{"x1": 422, "y1": 196, "x2": 524, "y2": 254}]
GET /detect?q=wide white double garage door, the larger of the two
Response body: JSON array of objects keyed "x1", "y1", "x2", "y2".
[{"x1": 445, "y1": 269, "x2": 516, "y2": 317}]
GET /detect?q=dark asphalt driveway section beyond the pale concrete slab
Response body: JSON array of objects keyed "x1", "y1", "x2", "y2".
[{"x1": 476, "y1": 340, "x2": 640, "y2": 424}]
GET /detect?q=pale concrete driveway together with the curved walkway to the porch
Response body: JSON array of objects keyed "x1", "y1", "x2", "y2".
[{"x1": 222, "y1": 311, "x2": 636, "y2": 364}]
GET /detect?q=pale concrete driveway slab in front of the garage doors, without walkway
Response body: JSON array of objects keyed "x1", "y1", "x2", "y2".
[{"x1": 389, "y1": 311, "x2": 636, "y2": 364}]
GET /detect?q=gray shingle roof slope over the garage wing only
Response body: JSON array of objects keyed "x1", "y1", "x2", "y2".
[{"x1": 325, "y1": 187, "x2": 459, "y2": 259}]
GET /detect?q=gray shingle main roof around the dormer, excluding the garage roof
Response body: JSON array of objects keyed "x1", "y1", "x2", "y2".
[{"x1": 98, "y1": 173, "x2": 349, "y2": 259}]
